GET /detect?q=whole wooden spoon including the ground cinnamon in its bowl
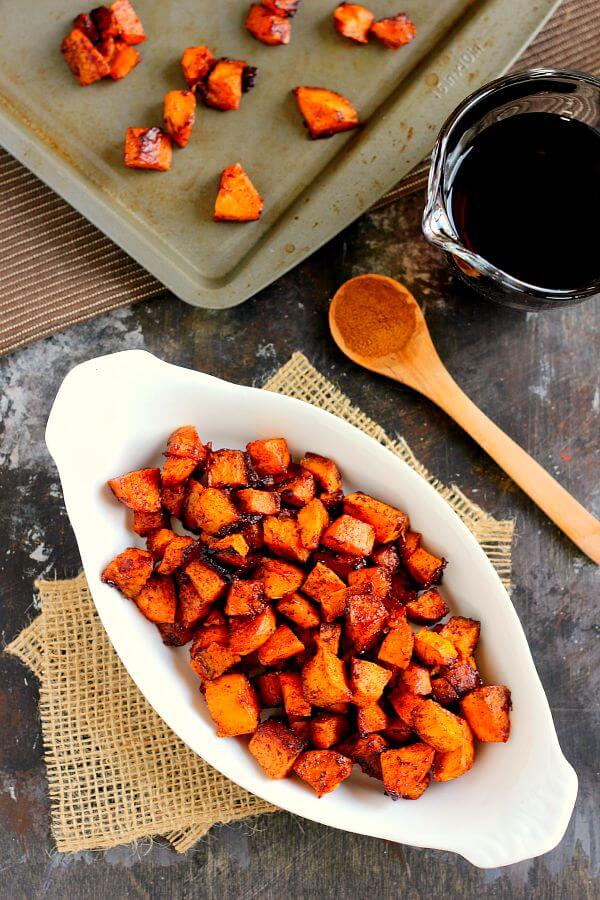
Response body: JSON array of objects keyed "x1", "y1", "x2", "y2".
[{"x1": 329, "y1": 275, "x2": 600, "y2": 565}]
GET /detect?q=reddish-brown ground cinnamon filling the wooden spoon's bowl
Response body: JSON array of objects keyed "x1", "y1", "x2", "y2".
[{"x1": 335, "y1": 275, "x2": 415, "y2": 358}]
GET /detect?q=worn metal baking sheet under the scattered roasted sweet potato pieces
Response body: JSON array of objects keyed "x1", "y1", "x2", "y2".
[{"x1": 0, "y1": 0, "x2": 557, "y2": 307}]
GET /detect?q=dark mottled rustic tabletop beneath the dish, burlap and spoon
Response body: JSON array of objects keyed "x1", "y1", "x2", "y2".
[{"x1": 0, "y1": 195, "x2": 600, "y2": 900}]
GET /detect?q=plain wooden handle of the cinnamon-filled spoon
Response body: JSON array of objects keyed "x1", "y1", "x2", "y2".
[{"x1": 418, "y1": 363, "x2": 600, "y2": 565}]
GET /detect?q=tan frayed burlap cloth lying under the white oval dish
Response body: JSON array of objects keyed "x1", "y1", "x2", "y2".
[{"x1": 6, "y1": 353, "x2": 514, "y2": 853}]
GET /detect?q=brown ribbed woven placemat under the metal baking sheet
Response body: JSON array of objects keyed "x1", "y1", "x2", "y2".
[{"x1": 0, "y1": 0, "x2": 600, "y2": 354}]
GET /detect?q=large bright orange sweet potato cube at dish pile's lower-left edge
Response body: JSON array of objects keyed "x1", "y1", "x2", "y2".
[{"x1": 205, "y1": 672, "x2": 260, "y2": 737}]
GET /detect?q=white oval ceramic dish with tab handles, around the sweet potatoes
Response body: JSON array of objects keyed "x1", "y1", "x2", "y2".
[{"x1": 46, "y1": 350, "x2": 577, "y2": 868}]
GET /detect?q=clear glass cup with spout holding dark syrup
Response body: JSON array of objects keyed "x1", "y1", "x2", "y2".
[{"x1": 423, "y1": 69, "x2": 600, "y2": 310}]
